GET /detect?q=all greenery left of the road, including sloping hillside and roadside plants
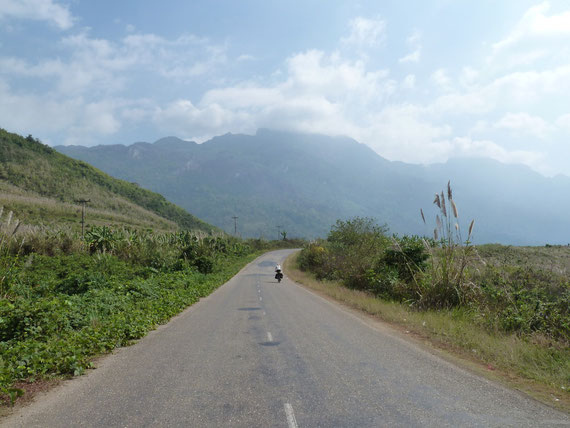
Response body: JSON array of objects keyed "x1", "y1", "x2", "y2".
[{"x1": 0, "y1": 129, "x2": 303, "y2": 403}]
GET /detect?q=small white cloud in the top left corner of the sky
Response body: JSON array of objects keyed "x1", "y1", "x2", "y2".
[{"x1": 0, "y1": 0, "x2": 74, "y2": 30}]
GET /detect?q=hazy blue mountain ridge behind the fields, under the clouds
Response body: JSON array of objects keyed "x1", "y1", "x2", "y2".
[{"x1": 56, "y1": 130, "x2": 570, "y2": 245}]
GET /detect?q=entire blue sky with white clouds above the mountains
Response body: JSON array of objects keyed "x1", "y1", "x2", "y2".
[{"x1": 0, "y1": 0, "x2": 570, "y2": 176}]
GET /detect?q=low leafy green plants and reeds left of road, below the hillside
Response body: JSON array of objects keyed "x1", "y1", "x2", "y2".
[{"x1": 0, "y1": 207, "x2": 298, "y2": 401}]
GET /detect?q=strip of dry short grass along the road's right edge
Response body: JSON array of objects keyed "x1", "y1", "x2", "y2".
[{"x1": 284, "y1": 253, "x2": 570, "y2": 411}]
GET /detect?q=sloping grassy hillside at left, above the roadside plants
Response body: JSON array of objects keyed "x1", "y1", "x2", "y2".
[{"x1": 0, "y1": 129, "x2": 215, "y2": 232}]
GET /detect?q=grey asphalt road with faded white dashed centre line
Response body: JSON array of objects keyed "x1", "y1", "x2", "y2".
[{"x1": 0, "y1": 251, "x2": 570, "y2": 427}]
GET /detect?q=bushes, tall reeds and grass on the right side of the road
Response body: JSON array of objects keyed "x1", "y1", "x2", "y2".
[{"x1": 297, "y1": 186, "x2": 570, "y2": 402}]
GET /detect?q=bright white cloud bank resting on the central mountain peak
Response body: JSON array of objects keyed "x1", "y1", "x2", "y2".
[{"x1": 154, "y1": 50, "x2": 400, "y2": 145}]
